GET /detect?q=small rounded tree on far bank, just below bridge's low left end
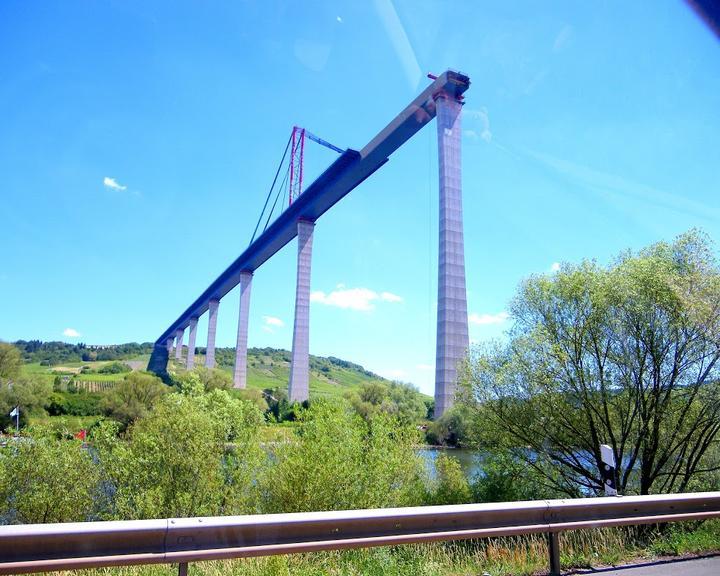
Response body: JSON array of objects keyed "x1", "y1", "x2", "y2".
[{"x1": 102, "y1": 372, "x2": 168, "y2": 428}]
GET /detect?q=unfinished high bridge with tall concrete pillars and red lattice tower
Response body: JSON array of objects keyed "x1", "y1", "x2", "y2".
[{"x1": 148, "y1": 70, "x2": 470, "y2": 417}]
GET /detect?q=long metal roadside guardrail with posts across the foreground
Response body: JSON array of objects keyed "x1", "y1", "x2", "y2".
[{"x1": 0, "y1": 492, "x2": 720, "y2": 574}]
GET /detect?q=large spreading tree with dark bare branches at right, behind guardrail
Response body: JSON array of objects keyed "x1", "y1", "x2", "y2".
[{"x1": 467, "y1": 231, "x2": 720, "y2": 494}]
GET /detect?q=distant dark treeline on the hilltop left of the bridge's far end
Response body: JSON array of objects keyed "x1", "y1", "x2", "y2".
[{"x1": 13, "y1": 340, "x2": 153, "y2": 366}]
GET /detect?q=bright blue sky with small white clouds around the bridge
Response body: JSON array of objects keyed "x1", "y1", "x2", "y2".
[{"x1": 0, "y1": 0, "x2": 720, "y2": 392}]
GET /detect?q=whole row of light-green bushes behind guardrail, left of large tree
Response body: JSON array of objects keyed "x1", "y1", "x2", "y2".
[{"x1": 0, "y1": 385, "x2": 472, "y2": 524}]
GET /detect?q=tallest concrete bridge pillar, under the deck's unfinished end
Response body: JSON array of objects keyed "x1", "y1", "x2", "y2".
[{"x1": 435, "y1": 94, "x2": 469, "y2": 418}]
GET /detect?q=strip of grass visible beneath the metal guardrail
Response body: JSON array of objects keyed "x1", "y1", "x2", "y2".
[{"x1": 53, "y1": 520, "x2": 720, "y2": 576}]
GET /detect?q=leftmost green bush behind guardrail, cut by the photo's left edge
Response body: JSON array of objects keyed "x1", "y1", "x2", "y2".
[{"x1": 0, "y1": 430, "x2": 101, "y2": 524}]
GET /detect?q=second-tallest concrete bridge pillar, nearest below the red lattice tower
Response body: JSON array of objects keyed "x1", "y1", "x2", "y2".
[{"x1": 288, "y1": 220, "x2": 315, "y2": 402}]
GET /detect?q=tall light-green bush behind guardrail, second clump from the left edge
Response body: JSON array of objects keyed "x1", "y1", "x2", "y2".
[{"x1": 96, "y1": 390, "x2": 263, "y2": 518}]
